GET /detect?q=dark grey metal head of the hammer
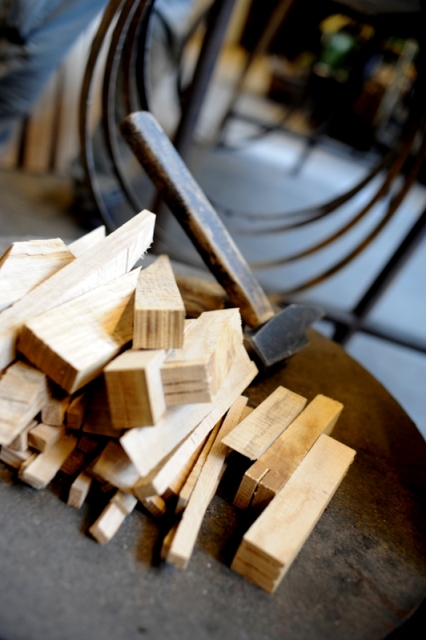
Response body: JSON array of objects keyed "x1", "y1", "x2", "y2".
[{"x1": 244, "y1": 304, "x2": 324, "y2": 371}]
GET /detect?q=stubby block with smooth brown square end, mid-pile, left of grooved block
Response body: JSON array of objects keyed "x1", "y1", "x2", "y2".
[{"x1": 104, "y1": 349, "x2": 167, "y2": 429}]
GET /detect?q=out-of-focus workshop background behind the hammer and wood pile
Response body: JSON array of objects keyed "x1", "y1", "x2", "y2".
[{"x1": 0, "y1": 0, "x2": 426, "y2": 437}]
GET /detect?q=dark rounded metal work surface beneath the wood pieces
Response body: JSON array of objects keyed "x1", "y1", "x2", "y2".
[{"x1": 0, "y1": 332, "x2": 426, "y2": 640}]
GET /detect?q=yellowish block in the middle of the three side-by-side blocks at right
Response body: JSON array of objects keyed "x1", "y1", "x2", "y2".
[{"x1": 234, "y1": 395, "x2": 343, "y2": 509}]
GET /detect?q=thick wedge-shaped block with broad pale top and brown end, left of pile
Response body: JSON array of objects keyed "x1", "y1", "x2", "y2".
[{"x1": 18, "y1": 269, "x2": 138, "y2": 393}]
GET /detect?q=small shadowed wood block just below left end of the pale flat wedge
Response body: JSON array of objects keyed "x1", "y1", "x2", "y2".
[{"x1": 92, "y1": 440, "x2": 140, "y2": 491}]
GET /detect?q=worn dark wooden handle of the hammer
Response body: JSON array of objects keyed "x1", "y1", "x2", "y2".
[{"x1": 121, "y1": 111, "x2": 274, "y2": 327}]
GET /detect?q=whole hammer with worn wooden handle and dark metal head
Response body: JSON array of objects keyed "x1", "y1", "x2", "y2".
[{"x1": 120, "y1": 111, "x2": 323, "y2": 371}]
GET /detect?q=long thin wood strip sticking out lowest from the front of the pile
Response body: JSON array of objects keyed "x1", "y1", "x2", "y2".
[{"x1": 167, "y1": 396, "x2": 247, "y2": 569}]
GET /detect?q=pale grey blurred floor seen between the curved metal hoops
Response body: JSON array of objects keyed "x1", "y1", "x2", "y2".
[{"x1": 0, "y1": 122, "x2": 426, "y2": 437}]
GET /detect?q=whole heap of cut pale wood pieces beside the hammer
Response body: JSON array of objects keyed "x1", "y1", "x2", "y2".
[{"x1": 0, "y1": 218, "x2": 354, "y2": 591}]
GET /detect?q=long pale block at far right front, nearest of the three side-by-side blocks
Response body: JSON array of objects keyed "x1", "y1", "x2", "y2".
[{"x1": 231, "y1": 434, "x2": 355, "y2": 593}]
